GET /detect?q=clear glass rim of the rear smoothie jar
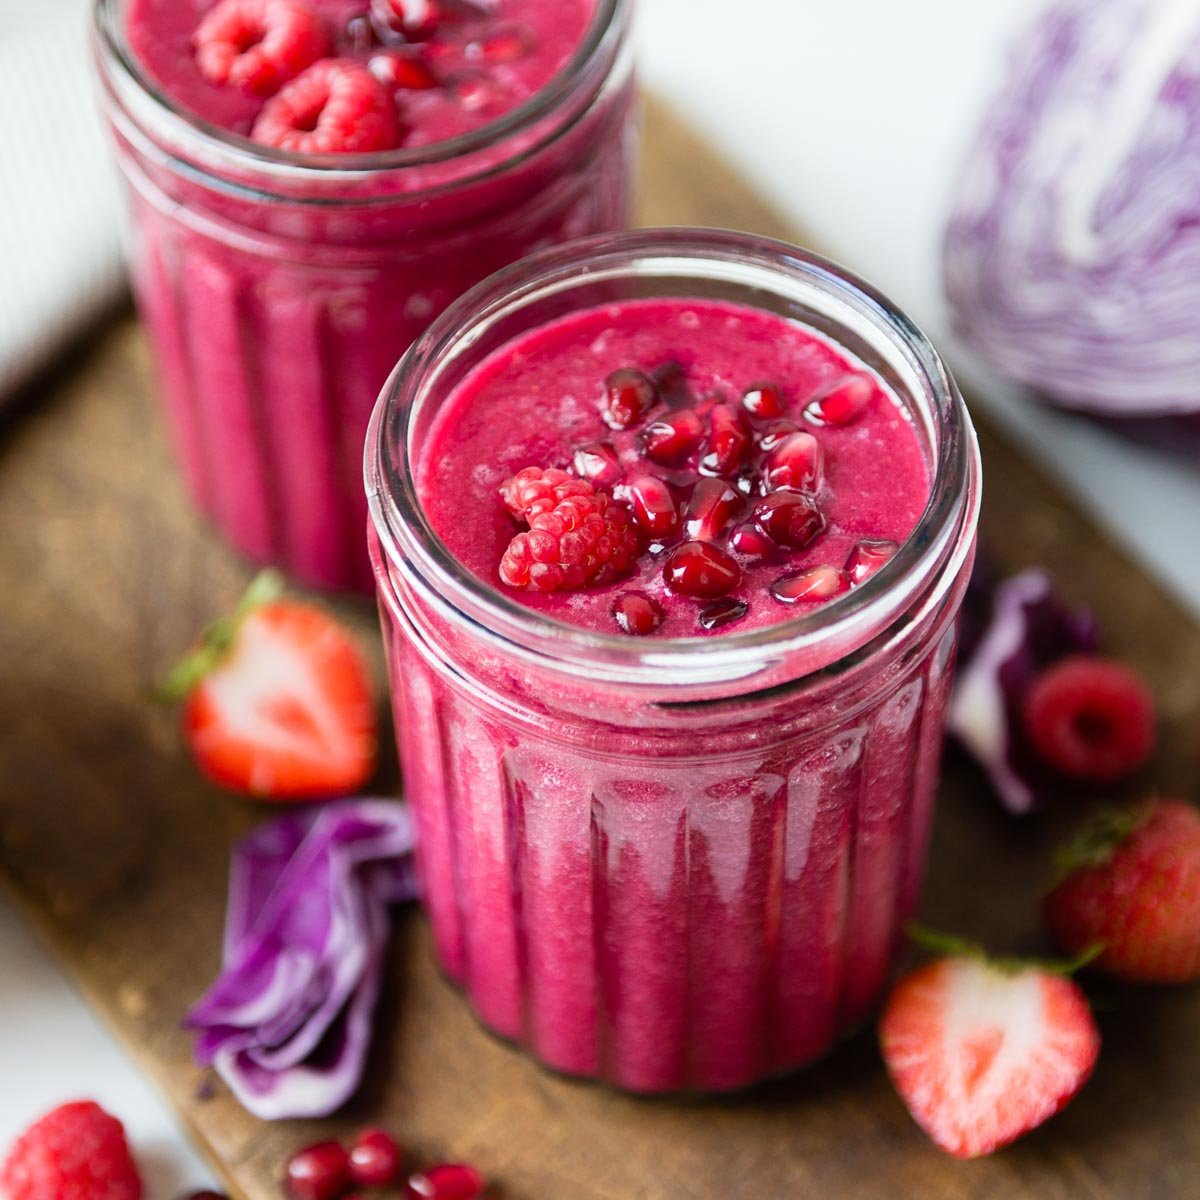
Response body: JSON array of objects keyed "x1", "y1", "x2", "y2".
[{"x1": 92, "y1": 0, "x2": 629, "y2": 182}]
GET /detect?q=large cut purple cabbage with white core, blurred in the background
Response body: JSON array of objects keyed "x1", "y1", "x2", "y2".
[{"x1": 943, "y1": 0, "x2": 1200, "y2": 418}]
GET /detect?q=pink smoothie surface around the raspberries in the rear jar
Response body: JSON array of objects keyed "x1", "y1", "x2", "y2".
[{"x1": 125, "y1": 0, "x2": 598, "y2": 149}]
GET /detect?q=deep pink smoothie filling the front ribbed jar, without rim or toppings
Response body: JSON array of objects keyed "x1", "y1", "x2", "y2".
[{"x1": 374, "y1": 292, "x2": 959, "y2": 1092}]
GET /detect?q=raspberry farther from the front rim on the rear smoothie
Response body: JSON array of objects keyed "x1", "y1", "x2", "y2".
[{"x1": 192, "y1": 0, "x2": 329, "y2": 96}]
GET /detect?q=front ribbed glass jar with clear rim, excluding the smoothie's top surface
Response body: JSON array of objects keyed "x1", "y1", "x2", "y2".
[{"x1": 366, "y1": 230, "x2": 979, "y2": 1092}]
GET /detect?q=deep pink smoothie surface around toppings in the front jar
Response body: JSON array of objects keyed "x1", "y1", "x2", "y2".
[{"x1": 415, "y1": 299, "x2": 930, "y2": 637}]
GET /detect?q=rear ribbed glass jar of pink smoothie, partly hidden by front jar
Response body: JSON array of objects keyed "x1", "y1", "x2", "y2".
[{"x1": 95, "y1": 0, "x2": 636, "y2": 590}]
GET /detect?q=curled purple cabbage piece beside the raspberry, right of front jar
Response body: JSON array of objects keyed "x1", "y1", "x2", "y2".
[{"x1": 949, "y1": 570, "x2": 1098, "y2": 814}]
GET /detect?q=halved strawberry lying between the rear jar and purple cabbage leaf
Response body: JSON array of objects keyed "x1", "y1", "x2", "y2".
[{"x1": 163, "y1": 572, "x2": 377, "y2": 800}]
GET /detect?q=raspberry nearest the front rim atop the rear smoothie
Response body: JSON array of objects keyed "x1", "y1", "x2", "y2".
[{"x1": 251, "y1": 59, "x2": 400, "y2": 154}]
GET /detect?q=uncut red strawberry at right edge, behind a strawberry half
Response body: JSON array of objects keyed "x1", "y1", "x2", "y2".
[{"x1": 1045, "y1": 800, "x2": 1200, "y2": 983}]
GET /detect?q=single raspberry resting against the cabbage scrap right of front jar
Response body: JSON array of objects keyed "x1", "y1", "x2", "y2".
[{"x1": 1025, "y1": 658, "x2": 1154, "y2": 784}]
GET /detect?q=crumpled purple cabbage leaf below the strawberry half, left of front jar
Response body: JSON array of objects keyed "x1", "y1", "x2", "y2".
[{"x1": 186, "y1": 799, "x2": 416, "y2": 1121}]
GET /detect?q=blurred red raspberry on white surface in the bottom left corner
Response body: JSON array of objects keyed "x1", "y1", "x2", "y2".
[{"x1": 0, "y1": 1100, "x2": 142, "y2": 1200}]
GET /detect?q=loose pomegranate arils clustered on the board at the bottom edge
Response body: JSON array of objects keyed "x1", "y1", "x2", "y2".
[{"x1": 286, "y1": 1129, "x2": 487, "y2": 1200}]
